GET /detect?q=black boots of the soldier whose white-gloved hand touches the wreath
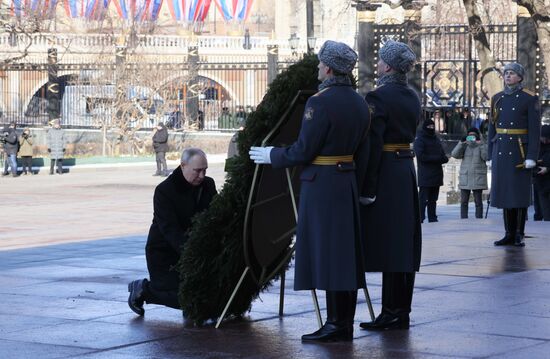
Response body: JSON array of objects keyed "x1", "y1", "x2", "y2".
[{"x1": 302, "y1": 290, "x2": 353, "y2": 342}]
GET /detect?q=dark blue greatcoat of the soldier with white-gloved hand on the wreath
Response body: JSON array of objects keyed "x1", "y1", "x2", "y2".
[{"x1": 270, "y1": 85, "x2": 369, "y2": 291}]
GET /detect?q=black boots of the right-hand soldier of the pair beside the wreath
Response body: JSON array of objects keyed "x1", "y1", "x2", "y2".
[{"x1": 360, "y1": 272, "x2": 414, "y2": 331}]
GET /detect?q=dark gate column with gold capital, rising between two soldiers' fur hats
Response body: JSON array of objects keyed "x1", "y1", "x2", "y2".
[{"x1": 356, "y1": 3, "x2": 381, "y2": 96}]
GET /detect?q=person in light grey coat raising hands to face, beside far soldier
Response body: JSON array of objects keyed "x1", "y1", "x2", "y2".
[{"x1": 451, "y1": 127, "x2": 487, "y2": 218}]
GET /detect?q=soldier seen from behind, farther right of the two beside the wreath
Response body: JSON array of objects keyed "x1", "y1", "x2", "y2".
[{"x1": 361, "y1": 41, "x2": 422, "y2": 330}]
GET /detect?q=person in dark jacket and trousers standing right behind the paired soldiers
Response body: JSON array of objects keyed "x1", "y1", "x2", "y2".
[{"x1": 414, "y1": 120, "x2": 449, "y2": 222}]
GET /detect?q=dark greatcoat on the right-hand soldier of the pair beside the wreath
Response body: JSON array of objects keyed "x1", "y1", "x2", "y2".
[{"x1": 361, "y1": 83, "x2": 422, "y2": 272}]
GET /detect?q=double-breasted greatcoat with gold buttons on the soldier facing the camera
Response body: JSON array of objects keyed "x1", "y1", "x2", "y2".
[{"x1": 488, "y1": 89, "x2": 540, "y2": 208}]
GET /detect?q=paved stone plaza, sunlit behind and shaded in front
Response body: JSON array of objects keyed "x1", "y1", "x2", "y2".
[{"x1": 0, "y1": 156, "x2": 550, "y2": 359}]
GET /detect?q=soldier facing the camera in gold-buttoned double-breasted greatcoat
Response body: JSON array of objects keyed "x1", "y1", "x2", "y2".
[{"x1": 488, "y1": 63, "x2": 540, "y2": 247}]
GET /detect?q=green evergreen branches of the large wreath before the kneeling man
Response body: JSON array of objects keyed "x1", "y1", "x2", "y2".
[{"x1": 177, "y1": 56, "x2": 319, "y2": 324}]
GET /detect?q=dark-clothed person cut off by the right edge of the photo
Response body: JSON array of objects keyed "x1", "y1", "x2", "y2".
[{"x1": 533, "y1": 125, "x2": 550, "y2": 221}]
